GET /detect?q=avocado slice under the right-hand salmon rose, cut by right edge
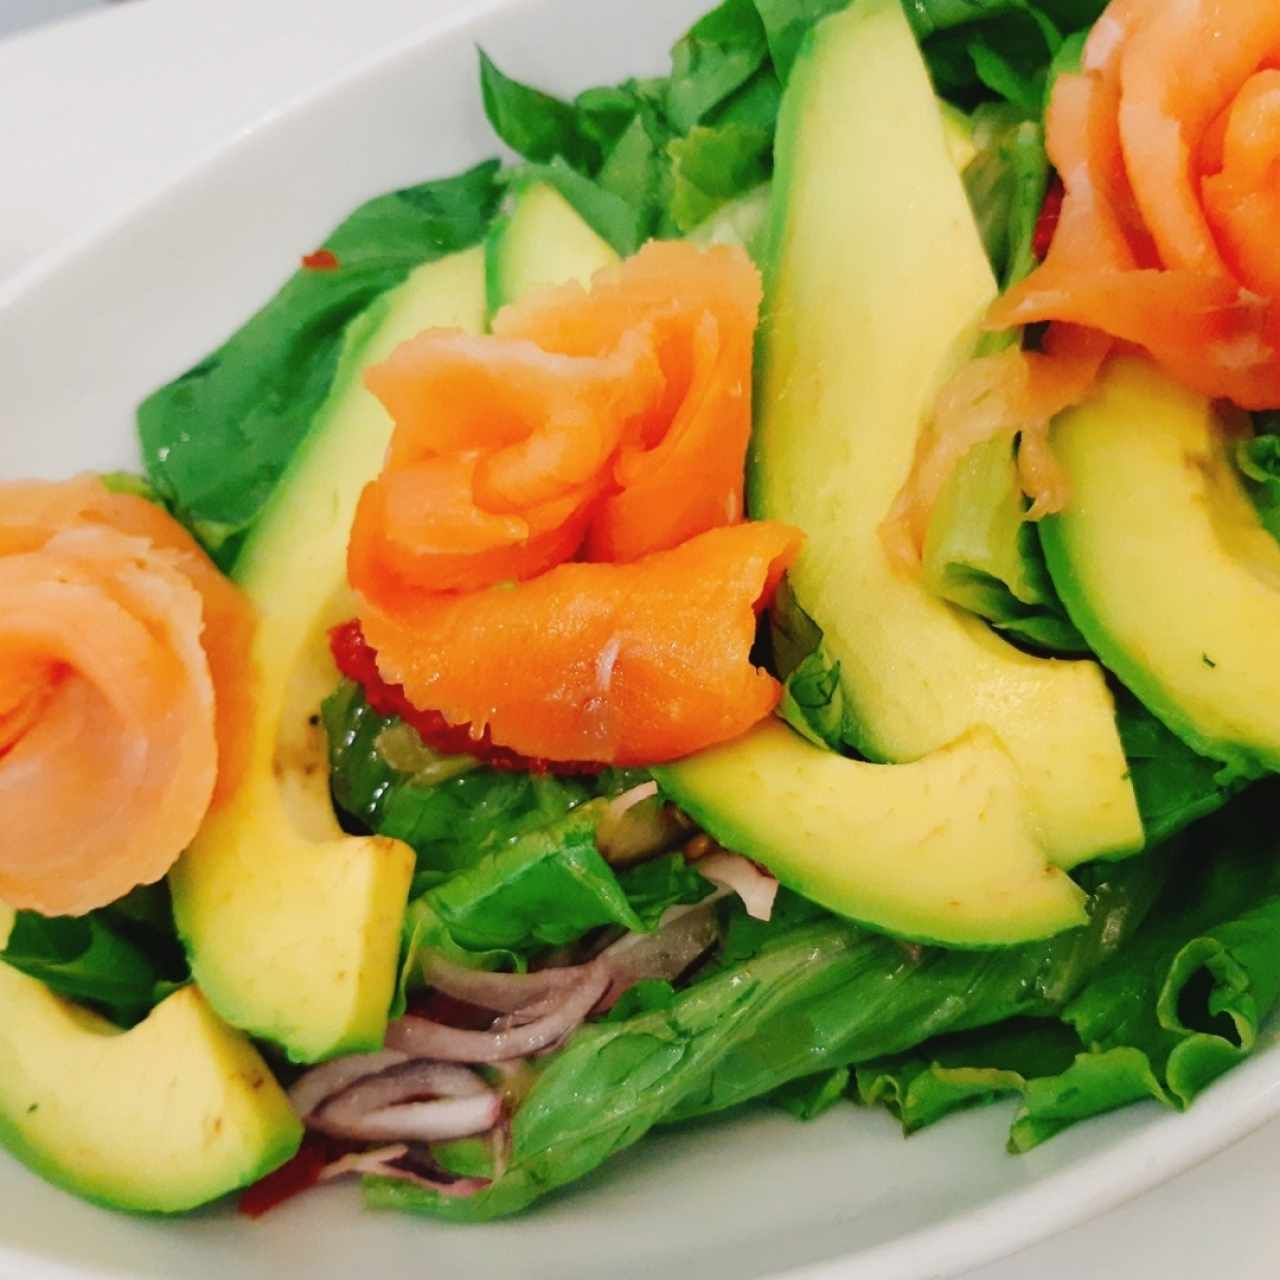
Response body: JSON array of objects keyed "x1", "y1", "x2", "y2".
[{"x1": 1041, "y1": 357, "x2": 1280, "y2": 778}]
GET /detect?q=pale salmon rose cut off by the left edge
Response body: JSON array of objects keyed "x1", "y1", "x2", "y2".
[{"x1": 0, "y1": 476, "x2": 253, "y2": 915}]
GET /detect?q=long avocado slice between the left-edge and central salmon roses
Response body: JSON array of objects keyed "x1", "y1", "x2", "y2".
[{"x1": 170, "y1": 247, "x2": 485, "y2": 1062}]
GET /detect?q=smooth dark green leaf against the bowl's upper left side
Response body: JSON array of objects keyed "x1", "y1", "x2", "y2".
[{"x1": 138, "y1": 161, "x2": 500, "y2": 568}]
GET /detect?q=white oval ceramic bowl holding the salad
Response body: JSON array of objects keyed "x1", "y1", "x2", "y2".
[{"x1": 0, "y1": 0, "x2": 1280, "y2": 1280}]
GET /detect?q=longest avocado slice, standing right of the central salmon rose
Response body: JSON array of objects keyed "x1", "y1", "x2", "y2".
[{"x1": 748, "y1": 0, "x2": 1143, "y2": 868}]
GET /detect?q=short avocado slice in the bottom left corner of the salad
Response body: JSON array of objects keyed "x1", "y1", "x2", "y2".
[{"x1": 0, "y1": 906, "x2": 302, "y2": 1213}]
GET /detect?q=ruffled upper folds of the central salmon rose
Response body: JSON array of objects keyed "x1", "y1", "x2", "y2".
[{"x1": 348, "y1": 242, "x2": 760, "y2": 609}]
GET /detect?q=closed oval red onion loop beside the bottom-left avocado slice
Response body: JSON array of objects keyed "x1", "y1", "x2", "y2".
[{"x1": 307, "y1": 1062, "x2": 502, "y2": 1142}]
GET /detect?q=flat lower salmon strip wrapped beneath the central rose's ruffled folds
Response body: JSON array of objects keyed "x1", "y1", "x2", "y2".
[{"x1": 361, "y1": 522, "x2": 801, "y2": 764}]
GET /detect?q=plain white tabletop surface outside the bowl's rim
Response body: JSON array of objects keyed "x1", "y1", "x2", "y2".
[{"x1": 0, "y1": 0, "x2": 1280, "y2": 1280}]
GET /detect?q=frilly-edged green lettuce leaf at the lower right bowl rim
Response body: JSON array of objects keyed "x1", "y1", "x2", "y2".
[{"x1": 855, "y1": 787, "x2": 1280, "y2": 1151}]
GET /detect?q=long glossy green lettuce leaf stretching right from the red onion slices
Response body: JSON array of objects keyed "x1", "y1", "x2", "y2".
[{"x1": 366, "y1": 859, "x2": 1161, "y2": 1221}]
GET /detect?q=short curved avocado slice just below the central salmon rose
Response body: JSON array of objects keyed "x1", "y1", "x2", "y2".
[{"x1": 654, "y1": 721, "x2": 1087, "y2": 946}]
